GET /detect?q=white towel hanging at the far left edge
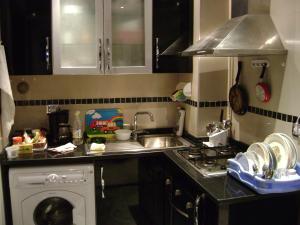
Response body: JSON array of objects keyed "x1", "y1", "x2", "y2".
[{"x1": 0, "y1": 45, "x2": 15, "y2": 147}]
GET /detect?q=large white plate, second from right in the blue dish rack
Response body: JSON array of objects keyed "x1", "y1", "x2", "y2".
[{"x1": 264, "y1": 133, "x2": 291, "y2": 169}]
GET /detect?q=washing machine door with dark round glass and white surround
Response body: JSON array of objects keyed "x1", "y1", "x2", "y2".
[{"x1": 22, "y1": 191, "x2": 87, "y2": 225}]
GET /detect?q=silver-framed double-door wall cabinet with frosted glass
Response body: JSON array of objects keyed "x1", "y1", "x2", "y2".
[{"x1": 52, "y1": 0, "x2": 152, "y2": 74}]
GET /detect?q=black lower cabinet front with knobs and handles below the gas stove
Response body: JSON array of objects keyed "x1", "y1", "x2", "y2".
[{"x1": 164, "y1": 159, "x2": 218, "y2": 225}]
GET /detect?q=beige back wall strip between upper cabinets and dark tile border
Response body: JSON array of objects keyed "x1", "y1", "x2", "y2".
[{"x1": 11, "y1": 74, "x2": 180, "y2": 100}]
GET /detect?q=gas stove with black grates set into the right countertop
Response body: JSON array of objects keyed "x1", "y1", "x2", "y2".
[{"x1": 175, "y1": 146, "x2": 238, "y2": 177}]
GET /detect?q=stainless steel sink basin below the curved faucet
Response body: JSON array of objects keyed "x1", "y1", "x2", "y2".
[{"x1": 138, "y1": 135, "x2": 184, "y2": 148}]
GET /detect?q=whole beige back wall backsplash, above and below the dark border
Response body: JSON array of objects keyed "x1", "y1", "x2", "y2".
[{"x1": 11, "y1": 74, "x2": 188, "y2": 129}]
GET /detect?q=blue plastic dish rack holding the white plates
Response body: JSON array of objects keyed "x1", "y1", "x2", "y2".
[{"x1": 227, "y1": 159, "x2": 300, "y2": 194}]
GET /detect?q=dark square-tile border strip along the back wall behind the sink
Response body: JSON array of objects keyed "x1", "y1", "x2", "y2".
[{"x1": 15, "y1": 97, "x2": 172, "y2": 106}]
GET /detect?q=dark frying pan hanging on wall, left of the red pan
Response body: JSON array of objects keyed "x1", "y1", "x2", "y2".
[{"x1": 229, "y1": 61, "x2": 249, "y2": 115}]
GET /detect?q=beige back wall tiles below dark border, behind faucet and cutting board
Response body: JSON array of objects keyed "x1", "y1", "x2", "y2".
[{"x1": 14, "y1": 102, "x2": 177, "y2": 129}]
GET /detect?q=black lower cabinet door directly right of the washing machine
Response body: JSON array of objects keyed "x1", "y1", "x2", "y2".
[{"x1": 95, "y1": 158, "x2": 152, "y2": 225}]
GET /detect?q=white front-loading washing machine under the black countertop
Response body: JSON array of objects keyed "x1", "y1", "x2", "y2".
[{"x1": 9, "y1": 164, "x2": 96, "y2": 225}]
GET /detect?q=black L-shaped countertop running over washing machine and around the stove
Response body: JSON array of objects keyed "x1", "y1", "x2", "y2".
[{"x1": 1, "y1": 139, "x2": 298, "y2": 204}]
